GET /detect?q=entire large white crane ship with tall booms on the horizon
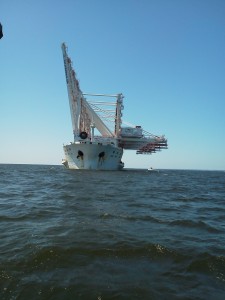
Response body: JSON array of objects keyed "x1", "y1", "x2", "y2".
[{"x1": 62, "y1": 43, "x2": 167, "y2": 170}]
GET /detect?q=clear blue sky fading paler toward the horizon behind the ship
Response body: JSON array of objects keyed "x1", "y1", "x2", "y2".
[{"x1": 0, "y1": 0, "x2": 225, "y2": 170}]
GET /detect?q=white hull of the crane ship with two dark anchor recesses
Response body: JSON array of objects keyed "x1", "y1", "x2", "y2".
[{"x1": 62, "y1": 142, "x2": 123, "y2": 170}]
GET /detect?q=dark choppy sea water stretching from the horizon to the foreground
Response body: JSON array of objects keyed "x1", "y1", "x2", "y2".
[{"x1": 0, "y1": 164, "x2": 225, "y2": 300}]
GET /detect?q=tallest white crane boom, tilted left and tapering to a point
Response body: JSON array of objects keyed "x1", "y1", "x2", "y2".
[{"x1": 62, "y1": 43, "x2": 83, "y2": 141}]
